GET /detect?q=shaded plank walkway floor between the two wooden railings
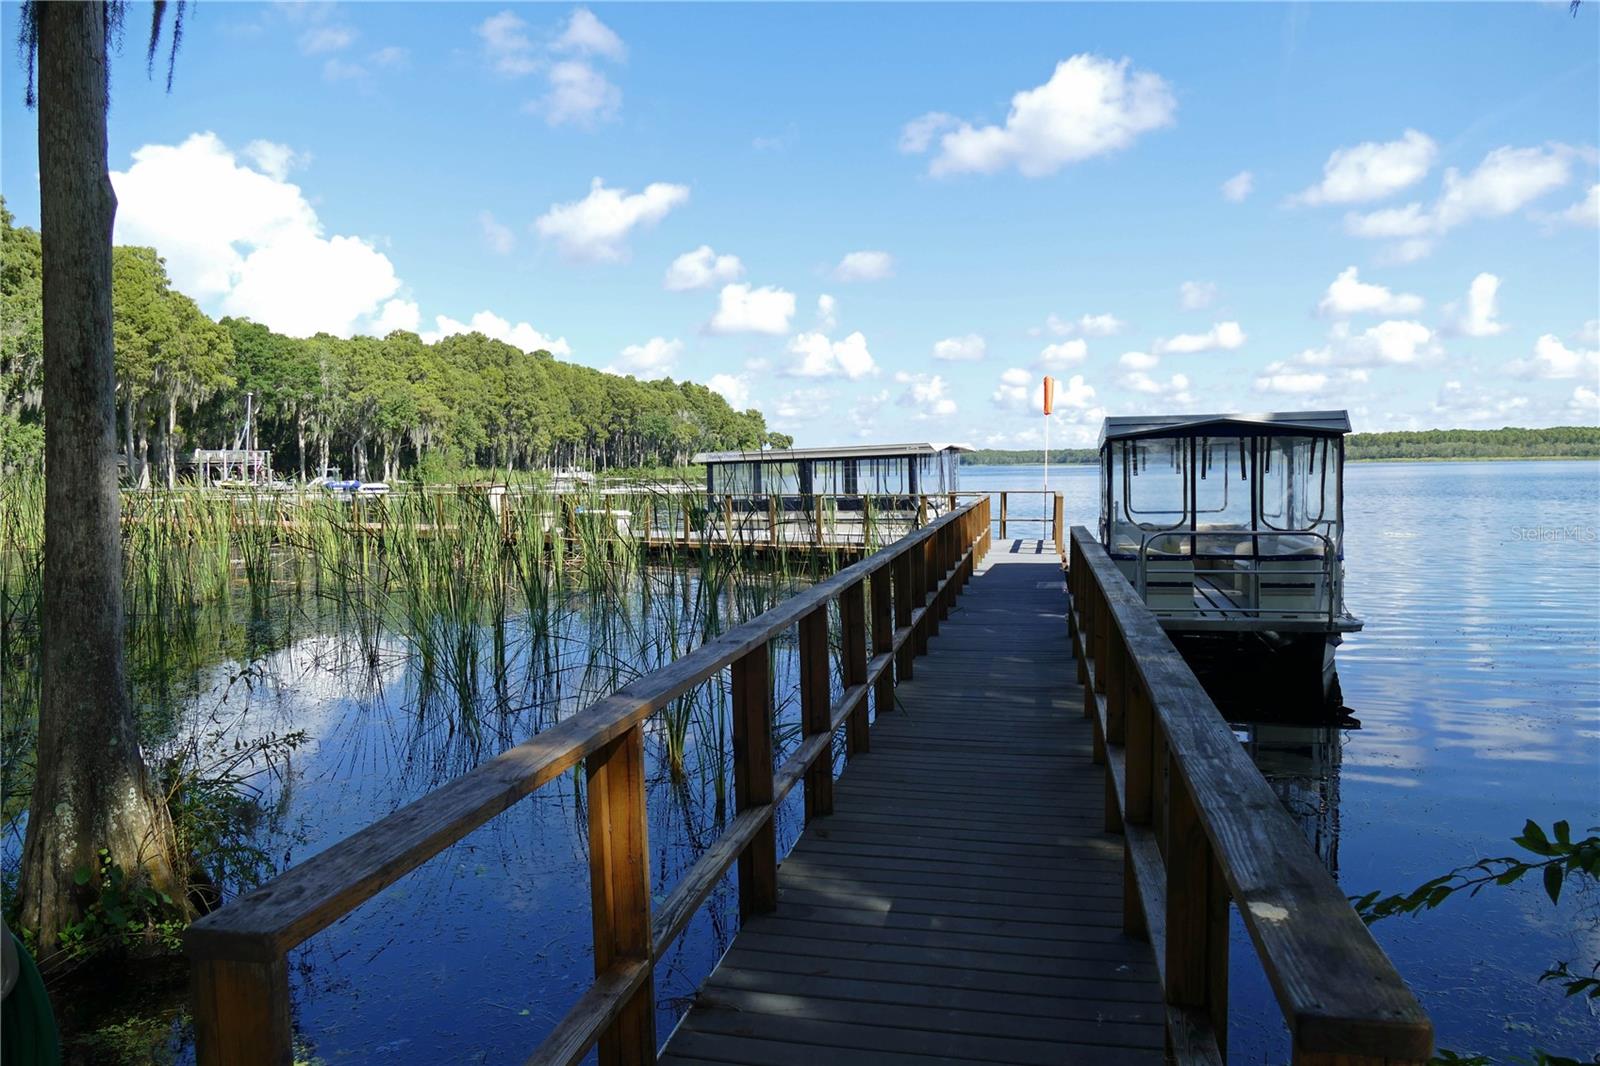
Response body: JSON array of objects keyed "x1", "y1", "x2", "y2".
[{"x1": 661, "y1": 539, "x2": 1165, "y2": 1066}]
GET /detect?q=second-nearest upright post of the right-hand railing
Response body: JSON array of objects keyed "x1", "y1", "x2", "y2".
[{"x1": 1166, "y1": 773, "x2": 1227, "y2": 1061}]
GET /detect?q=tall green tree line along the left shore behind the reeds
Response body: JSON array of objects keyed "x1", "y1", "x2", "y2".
[{"x1": 0, "y1": 202, "x2": 792, "y2": 487}]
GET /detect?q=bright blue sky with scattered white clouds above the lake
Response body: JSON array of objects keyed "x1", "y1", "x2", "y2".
[{"x1": 0, "y1": 3, "x2": 1600, "y2": 447}]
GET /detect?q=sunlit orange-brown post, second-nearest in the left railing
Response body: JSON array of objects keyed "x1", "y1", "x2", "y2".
[{"x1": 584, "y1": 725, "x2": 656, "y2": 1066}]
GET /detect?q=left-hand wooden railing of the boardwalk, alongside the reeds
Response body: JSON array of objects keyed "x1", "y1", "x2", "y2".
[{"x1": 184, "y1": 496, "x2": 990, "y2": 1066}]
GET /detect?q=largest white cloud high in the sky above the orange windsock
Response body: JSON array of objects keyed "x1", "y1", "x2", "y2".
[{"x1": 901, "y1": 54, "x2": 1178, "y2": 178}]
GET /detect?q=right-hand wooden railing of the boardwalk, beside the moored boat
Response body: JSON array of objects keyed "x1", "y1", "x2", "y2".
[{"x1": 1067, "y1": 527, "x2": 1434, "y2": 1066}]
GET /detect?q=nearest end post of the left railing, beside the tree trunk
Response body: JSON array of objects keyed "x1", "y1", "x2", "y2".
[{"x1": 192, "y1": 956, "x2": 294, "y2": 1066}]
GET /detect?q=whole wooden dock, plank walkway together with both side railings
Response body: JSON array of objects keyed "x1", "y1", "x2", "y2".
[{"x1": 184, "y1": 495, "x2": 1434, "y2": 1066}]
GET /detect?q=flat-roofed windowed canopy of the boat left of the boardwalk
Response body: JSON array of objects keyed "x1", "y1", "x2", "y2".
[{"x1": 694, "y1": 442, "x2": 971, "y2": 496}]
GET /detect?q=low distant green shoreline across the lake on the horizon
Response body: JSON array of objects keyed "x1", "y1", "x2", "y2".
[{"x1": 962, "y1": 426, "x2": 1600, "y2": 466}]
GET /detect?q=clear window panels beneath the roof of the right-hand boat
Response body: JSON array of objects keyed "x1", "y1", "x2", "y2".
[{"x1": 1101, "y1": 434, "x2": 1344, "y2": 559}]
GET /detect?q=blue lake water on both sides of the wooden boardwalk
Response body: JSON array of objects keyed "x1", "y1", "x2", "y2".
[{"x1": 6, "y1": 463, "x2": 1600, "y2": 1063}]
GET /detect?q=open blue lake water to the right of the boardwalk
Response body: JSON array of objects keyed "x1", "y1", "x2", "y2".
[{"x1": 962, "y1": 463, "x2": 1600, "y2": 1063}]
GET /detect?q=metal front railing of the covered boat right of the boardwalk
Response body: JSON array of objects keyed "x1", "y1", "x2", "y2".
[{"x1": 1133, "y1": 528, "x2": 1344, "y2": 627}]
